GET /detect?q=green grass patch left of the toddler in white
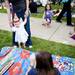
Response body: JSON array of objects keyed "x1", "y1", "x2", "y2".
[{"x1": 0, "y1": 30, "x2": 12, "y2": 48}]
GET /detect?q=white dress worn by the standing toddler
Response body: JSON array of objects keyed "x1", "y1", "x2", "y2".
[{"x1": 12, "y1": 18, "x2": 28, "y2": 43}]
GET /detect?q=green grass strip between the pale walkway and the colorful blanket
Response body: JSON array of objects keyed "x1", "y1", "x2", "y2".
[{"x1": 0, "y1": 30, "x2": 75, "y2": 58}]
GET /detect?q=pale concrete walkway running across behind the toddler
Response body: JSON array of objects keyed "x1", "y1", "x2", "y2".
[{"x1": 0, "y1": 14, "x2": 75, "y2": 46}]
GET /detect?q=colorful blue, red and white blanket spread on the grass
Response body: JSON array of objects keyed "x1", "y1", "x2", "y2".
[{"x1": 0, "y1": 47, "x2": 75, "y2": 75}]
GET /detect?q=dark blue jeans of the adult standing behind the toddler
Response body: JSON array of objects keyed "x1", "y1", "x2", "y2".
[{"x1": 13, "y1": 10, "x2": 32, "y2": 46}]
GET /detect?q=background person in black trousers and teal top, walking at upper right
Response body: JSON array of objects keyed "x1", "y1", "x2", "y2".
[{"x1": 56, "y1": 0, "x2": 73, "y2": 26}]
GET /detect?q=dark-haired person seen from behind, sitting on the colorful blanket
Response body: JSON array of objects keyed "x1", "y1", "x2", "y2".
[{"x1": 28, "y1": 51, "x2": 60, "y2": 75}]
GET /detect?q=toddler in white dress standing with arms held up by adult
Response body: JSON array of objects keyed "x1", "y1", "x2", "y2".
[{"x1": 12, "y1": 14, "x2": 28, "y2": 48}]
